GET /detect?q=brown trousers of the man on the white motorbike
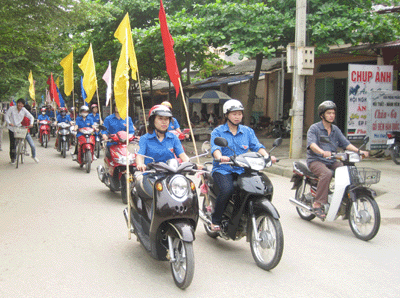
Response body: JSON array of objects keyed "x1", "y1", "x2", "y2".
[{"x1": 308, "y1": 161, "x2": 343, "y2": 205}]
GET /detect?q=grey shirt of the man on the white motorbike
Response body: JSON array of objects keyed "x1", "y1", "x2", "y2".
[{"x1": 307, "y1": 121, "x2": 350, "y2": 165}]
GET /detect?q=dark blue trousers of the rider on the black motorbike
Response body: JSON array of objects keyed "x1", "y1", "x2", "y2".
[{"x1": 212, "y1": 172, "x2": 237, "y2": 225}]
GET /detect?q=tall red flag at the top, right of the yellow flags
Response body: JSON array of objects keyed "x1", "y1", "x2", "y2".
[{"x1": 158, "y1": 0, "x2": 181, "y2": 97}]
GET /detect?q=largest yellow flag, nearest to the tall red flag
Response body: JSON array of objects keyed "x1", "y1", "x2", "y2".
[{"x1": 114, "y1": 13, "x2": 138, "y2": 119}]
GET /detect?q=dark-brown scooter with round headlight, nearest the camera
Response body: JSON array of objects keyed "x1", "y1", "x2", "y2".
[{"x1": 124, "y1": 153, "x2": 208, "y2": 289}]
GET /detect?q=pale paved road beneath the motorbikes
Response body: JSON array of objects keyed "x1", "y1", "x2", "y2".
[{"x1": 0, "y1": 136, "x2": 400, "y2": 297}]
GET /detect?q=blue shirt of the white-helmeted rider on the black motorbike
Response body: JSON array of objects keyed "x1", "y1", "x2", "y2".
[{"x1": 211, "y1": 123, "x2": 265, "y2": 175}]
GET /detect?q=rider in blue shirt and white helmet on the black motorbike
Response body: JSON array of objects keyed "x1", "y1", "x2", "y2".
[{"x1": 211, "y1": 99, "x2": 276, "y2": 231}]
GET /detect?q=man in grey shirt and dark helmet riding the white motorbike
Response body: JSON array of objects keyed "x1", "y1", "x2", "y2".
[{"x1": 307, "y1": 100, "x2": 368, "y2": 218}]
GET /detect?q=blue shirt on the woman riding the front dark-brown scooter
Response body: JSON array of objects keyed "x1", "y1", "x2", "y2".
[{"x1": 138, "y1": 131, "x2": 184, "y2": 164}]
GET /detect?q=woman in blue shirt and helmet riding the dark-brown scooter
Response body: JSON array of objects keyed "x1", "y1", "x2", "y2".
[{"x1": 136, "y1": 105, "x2": 189, "y2": 172}]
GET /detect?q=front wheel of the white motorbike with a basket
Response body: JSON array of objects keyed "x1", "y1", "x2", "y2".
[{"x1": 349, "y1": 194, "x2": 381, "y2": 241}]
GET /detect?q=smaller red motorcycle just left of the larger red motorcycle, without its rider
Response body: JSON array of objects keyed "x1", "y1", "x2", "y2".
[{"x1": 76, "y1": 127, "x2": 95, "y2": 173}]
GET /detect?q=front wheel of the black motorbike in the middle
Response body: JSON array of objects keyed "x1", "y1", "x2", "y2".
[{"x1": 249, "y1": 211, "x2": 283, "y2": 270}]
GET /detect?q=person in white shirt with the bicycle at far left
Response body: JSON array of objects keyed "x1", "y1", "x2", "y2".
[{"x1": 5, "y1": 98, "x2": 34, "y2": 164}]
